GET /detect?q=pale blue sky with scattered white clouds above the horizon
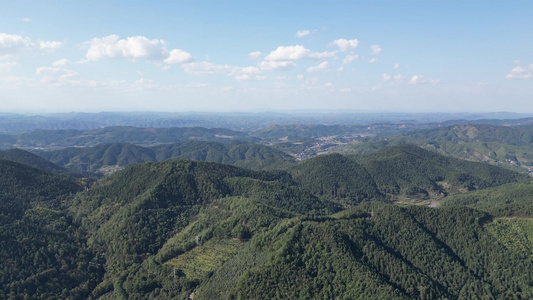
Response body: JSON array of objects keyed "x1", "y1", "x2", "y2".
[{"x1": 0, "y1": 0, "x2": 533, "y2": 113}]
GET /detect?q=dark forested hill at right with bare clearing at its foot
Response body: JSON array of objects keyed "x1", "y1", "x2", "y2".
[{"x1": 356, "y1": 144, "x2": 526, "y2": 198}]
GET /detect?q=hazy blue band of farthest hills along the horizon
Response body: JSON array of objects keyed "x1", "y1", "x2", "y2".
[{"x1": 0, "y1": 111, "x2": 533, "y2": 133}]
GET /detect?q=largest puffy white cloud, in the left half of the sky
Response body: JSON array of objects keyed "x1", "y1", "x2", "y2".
[{"x1": 85, "y1": 34, "x2": 192, "y2": 64}]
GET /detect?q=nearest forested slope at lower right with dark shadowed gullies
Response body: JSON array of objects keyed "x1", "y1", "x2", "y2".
[{"x1": 194, "y1": 205, "x2": 533, "y2": 299}]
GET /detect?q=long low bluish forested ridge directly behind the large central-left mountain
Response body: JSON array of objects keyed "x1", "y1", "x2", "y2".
[{"x1": 36, "y1": 140, "x2": 294, "y2": 173}]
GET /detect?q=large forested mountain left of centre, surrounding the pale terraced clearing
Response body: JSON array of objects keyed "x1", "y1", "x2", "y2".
[{"x1": 66, "y1": 160, "x2": 340, "y2": 299}]
